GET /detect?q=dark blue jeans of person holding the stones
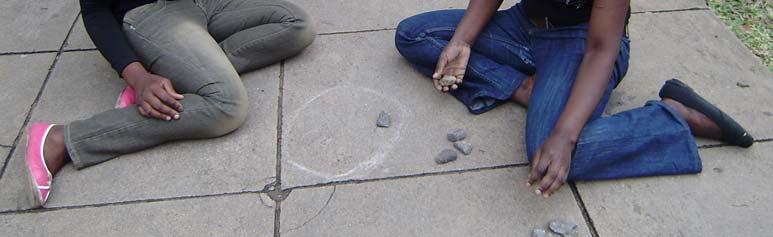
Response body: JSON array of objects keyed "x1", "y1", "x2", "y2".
[{"x1": 395, "y1": 4, "x2": 702, "y2": 180}]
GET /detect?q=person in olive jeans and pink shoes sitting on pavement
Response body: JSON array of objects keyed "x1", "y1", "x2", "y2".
[{"x1": 25, "y1": 0, "x2": 316, "y2": 207}]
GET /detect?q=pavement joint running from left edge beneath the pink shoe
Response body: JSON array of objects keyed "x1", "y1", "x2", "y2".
[{"x1": 0, "y1": 190, "x2": 268, "y2": 216}]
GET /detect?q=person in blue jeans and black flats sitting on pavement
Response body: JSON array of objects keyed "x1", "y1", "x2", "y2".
[{"x1": 395, "y1": 0, "x2": 754, "y2": 198}]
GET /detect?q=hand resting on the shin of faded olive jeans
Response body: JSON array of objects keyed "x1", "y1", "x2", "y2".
[{"x1": 122, "y1": 62, "x2": 184, "y2": 121}]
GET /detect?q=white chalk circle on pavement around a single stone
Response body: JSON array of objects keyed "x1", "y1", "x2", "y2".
[{"x1": 282, "y1": 86, "x2": 410, "y2": 181}]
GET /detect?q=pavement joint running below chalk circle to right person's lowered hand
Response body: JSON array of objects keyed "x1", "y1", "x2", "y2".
[{"x1": 286, "y1": 163, "x2": 529, "y2": 191}]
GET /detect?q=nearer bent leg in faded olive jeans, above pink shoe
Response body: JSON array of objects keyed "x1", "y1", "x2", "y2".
[{"x1": 65, "y1": 1, "x2": 248, "y2": 168}]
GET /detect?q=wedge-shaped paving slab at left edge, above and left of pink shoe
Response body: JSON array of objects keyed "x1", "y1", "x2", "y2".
[{"x1": 0, "y1": 53, "x2": 56, "y2": 146}]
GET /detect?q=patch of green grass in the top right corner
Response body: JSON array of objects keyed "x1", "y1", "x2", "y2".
[{"x1": 708, "y1": 0, "x2": 773, "y2": 71}]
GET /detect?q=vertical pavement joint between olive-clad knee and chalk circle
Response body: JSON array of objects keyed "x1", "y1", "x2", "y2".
[{"x1": 271, "y1": 60, "x2": 285, "y2": 237}]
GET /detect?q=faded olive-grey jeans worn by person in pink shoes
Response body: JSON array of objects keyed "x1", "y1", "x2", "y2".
[{"x1": 65, "y1": 0, "x2": 315, "y2": 168}]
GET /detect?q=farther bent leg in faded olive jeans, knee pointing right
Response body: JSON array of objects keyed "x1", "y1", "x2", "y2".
[{"x1": 201, "y1": 0, "x2": 316, "y2": 73}]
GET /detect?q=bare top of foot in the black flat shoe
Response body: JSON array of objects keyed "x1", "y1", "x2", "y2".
[{"x1": 662, "y1": 98, "x2": 722, "y2": 140}]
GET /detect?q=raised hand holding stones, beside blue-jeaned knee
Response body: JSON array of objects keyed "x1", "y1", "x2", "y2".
[{"x1": 432, "y1": 39, "x2": 470, "y2": 92}]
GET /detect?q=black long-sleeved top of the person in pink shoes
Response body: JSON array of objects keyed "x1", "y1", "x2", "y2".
[{"x1": 80, "y1": 0, "x2": 156, "y2": 74}]
